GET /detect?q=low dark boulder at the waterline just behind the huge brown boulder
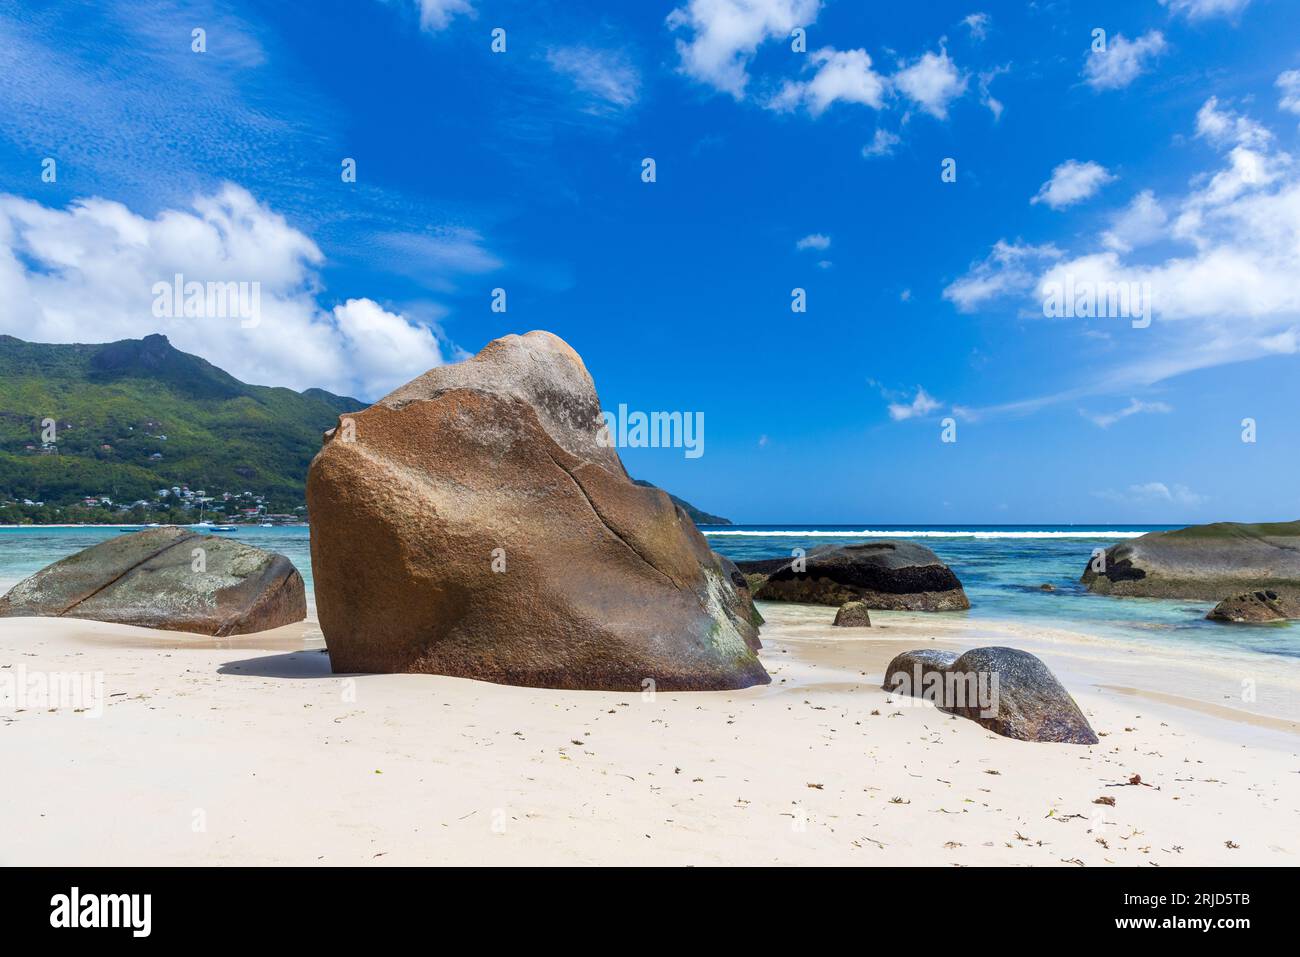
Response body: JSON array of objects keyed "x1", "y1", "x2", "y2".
[{"x1": 737, "y1": 541, "x2": 971, "y2": 611}]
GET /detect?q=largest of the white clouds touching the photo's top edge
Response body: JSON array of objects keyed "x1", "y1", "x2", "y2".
[{"x1": 667, "y1": 0, "x2": 822, "y2": 100}]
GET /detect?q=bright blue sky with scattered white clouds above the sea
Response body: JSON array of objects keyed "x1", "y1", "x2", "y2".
[{"x1": 0, "y1": 0, "x2": 1300, "y2": 524}]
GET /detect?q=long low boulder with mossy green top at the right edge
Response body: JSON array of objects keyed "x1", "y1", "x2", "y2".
[{"x1": 1082, "y1": 521, "x2": 1300, "y2": 602}]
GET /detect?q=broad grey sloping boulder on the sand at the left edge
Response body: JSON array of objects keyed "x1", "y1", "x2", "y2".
[{"x1": 0, "y1": 527, "x2": 307, "y2": 637}]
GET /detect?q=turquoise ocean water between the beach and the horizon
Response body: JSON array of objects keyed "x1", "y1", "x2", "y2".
[{"x1": 0, "y1": 524, "x2": 1300, "y2": 658}]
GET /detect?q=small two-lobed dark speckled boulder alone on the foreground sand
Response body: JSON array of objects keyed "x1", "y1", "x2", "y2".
[{"x1": 881, "y1": 648, "x2": 1097, "y2": 744}]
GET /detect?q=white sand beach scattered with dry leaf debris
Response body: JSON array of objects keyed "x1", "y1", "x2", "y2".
[{"x1": 0, "y1": 603, "x2": 1300, "y2": 867}]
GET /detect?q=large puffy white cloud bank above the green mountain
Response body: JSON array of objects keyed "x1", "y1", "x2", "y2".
[{"x1": 0, "y1": 185, "x2": 462, "y2": 398}]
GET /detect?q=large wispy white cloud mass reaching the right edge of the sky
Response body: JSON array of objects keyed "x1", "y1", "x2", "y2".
[{"x1": 945, "y1": 100, "x2": 1300, "y2": 412}]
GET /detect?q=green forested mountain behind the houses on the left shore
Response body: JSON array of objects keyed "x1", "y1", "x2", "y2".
[{"x1": 0, "y1": 335, "x2": 365, "y2": 512}]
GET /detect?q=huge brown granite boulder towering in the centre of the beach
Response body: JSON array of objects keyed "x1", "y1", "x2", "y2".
[{"x1": 307, "y1": 332, "x2": 771, "y2": 690}]
